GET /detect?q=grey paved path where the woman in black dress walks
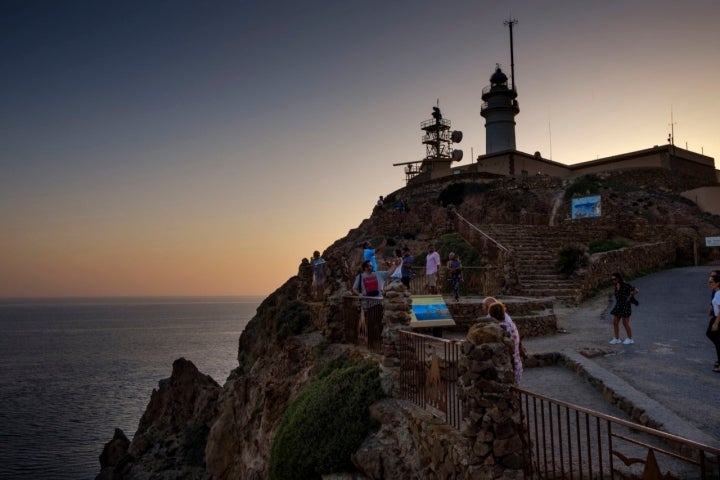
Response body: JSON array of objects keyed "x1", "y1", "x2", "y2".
[{"x1": 521, "y1": 267, "x2": 720, "y2": 448}]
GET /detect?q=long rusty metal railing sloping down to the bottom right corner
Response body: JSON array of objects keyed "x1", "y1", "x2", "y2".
[{"x1": 515, "y1": 388, "x2": 720, "y2": 480}]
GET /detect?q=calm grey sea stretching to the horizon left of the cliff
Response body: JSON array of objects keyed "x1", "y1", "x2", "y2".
[{"x1": 0, "y1": 297, "x2": 263, "y2": 480}]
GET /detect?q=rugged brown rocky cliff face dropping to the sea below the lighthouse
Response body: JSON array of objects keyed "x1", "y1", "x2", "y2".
[{"x1": 97, "y1": 172, "x2": 718, "y2": 480}]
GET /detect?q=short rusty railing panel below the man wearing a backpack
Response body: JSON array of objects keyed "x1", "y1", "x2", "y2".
[{"x1": 343, "y1": 296, "x2": 384, "y2": 352}]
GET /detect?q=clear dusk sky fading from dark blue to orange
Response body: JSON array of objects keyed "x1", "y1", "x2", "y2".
[{"x1": 0, "y1": 0, "x2": 720, "y2": 297}]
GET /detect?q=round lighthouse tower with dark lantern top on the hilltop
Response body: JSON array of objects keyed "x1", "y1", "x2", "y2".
[{"x1": 480, "y1": 65, "x2": 520, "y2": 155}]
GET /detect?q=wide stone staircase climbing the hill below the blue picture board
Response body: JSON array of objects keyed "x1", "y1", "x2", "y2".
[{"x1": 480, "y1": 224, "x2": 606, "y2": 304}]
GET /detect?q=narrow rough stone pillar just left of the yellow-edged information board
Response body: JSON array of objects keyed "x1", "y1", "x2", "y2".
[{"x1": 380, "y1": 280, "x2": 412, "y2": 395}]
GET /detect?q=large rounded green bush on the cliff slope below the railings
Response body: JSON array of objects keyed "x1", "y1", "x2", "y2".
[{"x1": 268, "y1": 360, "x2": 383, "y2": 480}]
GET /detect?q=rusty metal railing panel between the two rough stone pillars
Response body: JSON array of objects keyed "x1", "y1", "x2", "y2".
[{"x1": 398, "y1": 330, "x2": 463, "y2": 429}]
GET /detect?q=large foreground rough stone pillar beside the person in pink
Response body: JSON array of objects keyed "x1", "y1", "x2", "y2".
[{"x1": 458, "y1": 324, "x2": 524, "y2": 479}]
